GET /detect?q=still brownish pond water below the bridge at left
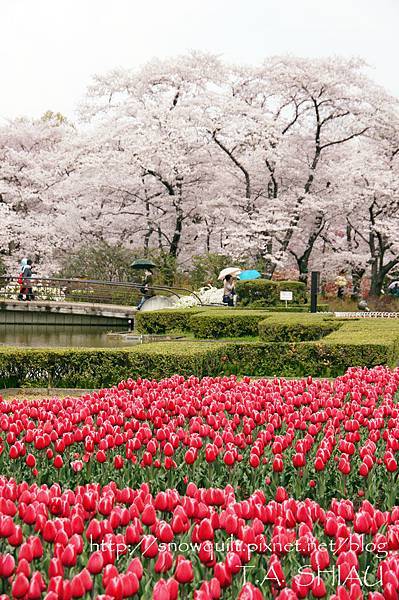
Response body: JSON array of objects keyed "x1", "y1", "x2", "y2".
[{"x1": 0, "y1": 325, "x2": 139, "y2": 348}]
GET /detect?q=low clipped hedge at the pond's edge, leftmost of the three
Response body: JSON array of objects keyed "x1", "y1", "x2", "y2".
[{"x1": 135, "y1": 308, "x2": 203, "y2": 334}]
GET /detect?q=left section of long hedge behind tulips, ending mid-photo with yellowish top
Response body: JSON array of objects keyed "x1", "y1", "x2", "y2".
[{"x1": 0, "y1": 342, "x2": 223, "y2": 389}]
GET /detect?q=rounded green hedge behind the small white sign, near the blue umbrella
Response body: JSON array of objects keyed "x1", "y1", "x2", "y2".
[{"x1": 236, "y1": 279, "x2": 307, "y2": 308}]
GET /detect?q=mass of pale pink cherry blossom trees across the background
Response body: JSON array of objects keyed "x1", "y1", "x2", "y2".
[{"x1": 0, "y1": 53, "x2": 399, "y2": 294}]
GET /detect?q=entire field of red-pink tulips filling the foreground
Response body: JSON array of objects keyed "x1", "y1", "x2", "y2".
[{"x1": 0, "y1": 367, "x2": 399, "y2": 600}]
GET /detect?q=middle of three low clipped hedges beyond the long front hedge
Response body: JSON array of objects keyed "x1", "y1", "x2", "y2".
[{"x1": 190, "y1": 310, "x2": 267, "y2": 339}]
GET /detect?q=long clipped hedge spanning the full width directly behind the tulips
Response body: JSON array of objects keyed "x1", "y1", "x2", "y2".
[{"x1": 0, "y1": 319, "x2": 399, "y2": 388}]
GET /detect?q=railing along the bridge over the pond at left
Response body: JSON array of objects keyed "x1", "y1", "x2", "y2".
[{"x1": 0, "y1": 275, "x2": 202, "y2": 306}]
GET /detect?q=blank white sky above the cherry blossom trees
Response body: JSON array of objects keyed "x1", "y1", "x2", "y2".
[{"x1": 0, "y1": 0, "x2": 399, "y2": 120}]
